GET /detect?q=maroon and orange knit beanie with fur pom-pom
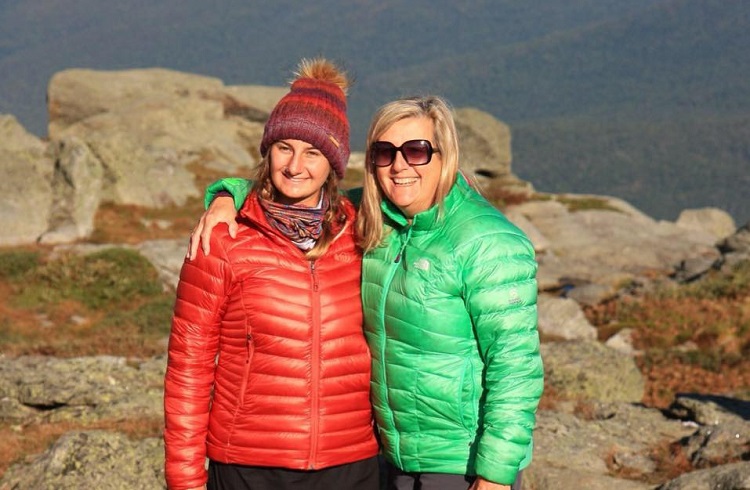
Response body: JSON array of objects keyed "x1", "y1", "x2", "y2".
[{"x1": 260, "y1": 58, "x2": 349, "y2": 179}]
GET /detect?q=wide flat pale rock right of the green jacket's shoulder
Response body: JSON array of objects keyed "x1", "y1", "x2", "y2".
[{"x1": 510, "y1": 195, "x2": 721, "y2": 305}]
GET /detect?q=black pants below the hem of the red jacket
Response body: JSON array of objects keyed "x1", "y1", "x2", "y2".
[{"x1": 207, "y1": 456, "x2": 380, "y2": 490}]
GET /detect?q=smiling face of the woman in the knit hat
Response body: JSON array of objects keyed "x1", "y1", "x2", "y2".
[{"x1": 269, "y1": 139, "x2": 331, "y2": 207}]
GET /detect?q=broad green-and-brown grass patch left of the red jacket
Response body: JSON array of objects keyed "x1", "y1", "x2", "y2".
[{"x1": 0, "y1": 249, "x2": 174, "y2": 357}]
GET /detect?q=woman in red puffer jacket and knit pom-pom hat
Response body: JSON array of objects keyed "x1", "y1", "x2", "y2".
[{"x1": 164, "y1": 59, "x2": 378, "y2": 490}]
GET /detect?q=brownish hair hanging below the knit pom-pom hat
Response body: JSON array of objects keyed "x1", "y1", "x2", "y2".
[{"x1": 251, "y1": 151, "x2": 346, "y2": 260}]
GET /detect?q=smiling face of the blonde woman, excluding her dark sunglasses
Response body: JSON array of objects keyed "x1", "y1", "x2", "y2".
[{"x1": 375, "y1": 117, "x2": 443, "y2": 218}]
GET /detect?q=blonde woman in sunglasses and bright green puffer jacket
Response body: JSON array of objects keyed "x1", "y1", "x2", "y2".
[{"x1": 193, "y1": 96, "x2": 543, "y2": 490}]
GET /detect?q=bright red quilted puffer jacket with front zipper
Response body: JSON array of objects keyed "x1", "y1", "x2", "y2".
[{"x1": 164, "y1": 194, "x2": 378, "y2": 489}]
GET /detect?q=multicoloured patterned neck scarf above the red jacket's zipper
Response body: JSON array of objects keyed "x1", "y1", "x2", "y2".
[{"x1": 258, "y1": 196, "x2": 328, "y2": 251}]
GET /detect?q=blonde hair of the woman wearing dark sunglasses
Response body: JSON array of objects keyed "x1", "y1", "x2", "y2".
[{"x1": 357, "y1": 95, "x2": 459, "y2": 252}]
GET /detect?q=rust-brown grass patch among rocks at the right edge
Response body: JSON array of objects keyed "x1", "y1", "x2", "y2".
[{"x1": 586, "y1": 264, "x2": 750, "y2": 408}]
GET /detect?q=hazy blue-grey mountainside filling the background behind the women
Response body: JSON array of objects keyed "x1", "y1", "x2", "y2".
[{"x1": 0, "y1": 0, "x2": 750, "y2": 224}]
